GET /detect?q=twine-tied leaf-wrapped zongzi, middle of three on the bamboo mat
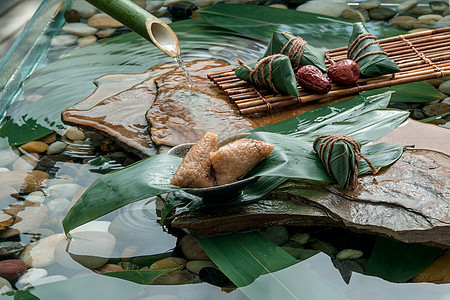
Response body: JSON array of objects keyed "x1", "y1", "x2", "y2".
[{"x1": 264, "y1": 31, "x2": 327, "y2": 73}]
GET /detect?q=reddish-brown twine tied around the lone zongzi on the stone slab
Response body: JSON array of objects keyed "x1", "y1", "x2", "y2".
[{"x1": 313, "y1": 134, "x2": 379, "y2": 189}]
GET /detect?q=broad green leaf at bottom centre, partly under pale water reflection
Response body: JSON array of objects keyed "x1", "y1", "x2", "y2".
[{"x1": 199, "y1": 232, "x2": 347, "y2": 300}]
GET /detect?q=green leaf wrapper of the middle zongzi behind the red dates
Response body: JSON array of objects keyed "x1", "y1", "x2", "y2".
[{"x1": 264, "y1": 31, "x2": 327, "y2": 73}]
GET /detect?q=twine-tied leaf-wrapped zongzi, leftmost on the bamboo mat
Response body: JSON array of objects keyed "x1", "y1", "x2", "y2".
[{"x1": 235, "y1": 54, "x2": 299, "y2": 97}]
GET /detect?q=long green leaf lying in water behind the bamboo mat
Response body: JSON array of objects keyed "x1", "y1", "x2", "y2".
[{"x1": 197, "y1": 4, "x2": 404, "y2": 49}]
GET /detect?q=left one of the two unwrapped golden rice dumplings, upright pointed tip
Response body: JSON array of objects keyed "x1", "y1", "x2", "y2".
[{"x1": 170, "y1": 132, "x2": 218, "y2": 188}]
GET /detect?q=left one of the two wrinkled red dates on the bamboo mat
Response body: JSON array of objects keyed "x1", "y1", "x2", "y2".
[{"x1": 295, "y1": 65, "x2": 331, "y2": 94}]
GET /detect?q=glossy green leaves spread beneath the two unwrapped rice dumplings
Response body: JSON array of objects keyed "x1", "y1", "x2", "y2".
[{"x1": 63, "y1": 93, "x2": 408, "y2": 233}]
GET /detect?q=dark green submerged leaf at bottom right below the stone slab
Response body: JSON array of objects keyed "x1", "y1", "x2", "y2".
[{"x1": 365, "y1": 237, "x2": 442, "y2": 282}]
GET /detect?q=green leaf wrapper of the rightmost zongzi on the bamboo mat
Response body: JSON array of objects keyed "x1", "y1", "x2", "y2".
[{"x1": 348, "y1": 23, "x2": 400, "y2": 76}]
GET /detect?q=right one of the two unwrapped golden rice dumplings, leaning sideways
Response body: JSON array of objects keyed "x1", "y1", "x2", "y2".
[{"x1": 210, "y1": 139, "x2": 273, "y2": 185}]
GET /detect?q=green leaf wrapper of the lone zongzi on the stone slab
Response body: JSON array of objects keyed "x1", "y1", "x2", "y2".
[{"x1": 314, "y1": 138, "x2": 356, "y2": 191}]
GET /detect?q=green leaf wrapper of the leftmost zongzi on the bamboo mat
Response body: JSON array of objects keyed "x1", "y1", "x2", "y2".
[{"x1": 235, "y1": 56, "x2": 299, "y2": 97}]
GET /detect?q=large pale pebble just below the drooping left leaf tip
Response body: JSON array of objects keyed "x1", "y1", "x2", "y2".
[{"x1": 67, "y1": 231, "x2": 116, "y2": 269}]
